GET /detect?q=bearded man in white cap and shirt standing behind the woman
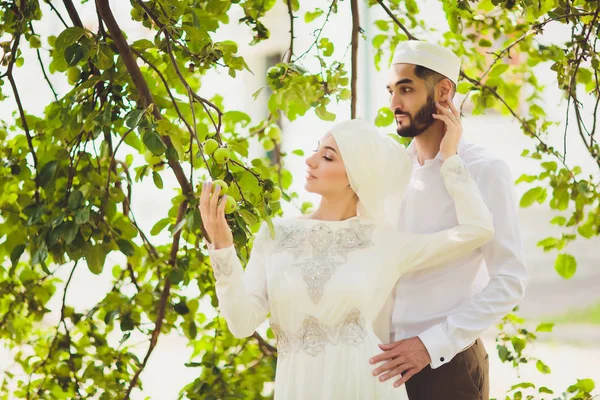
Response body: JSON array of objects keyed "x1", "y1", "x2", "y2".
[{"x1": 370, "y1": 41, "x2": 527, "y2": 400}]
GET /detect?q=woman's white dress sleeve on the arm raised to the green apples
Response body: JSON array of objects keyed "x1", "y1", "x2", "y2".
[{"x1": 209, "y1": 225, "x2": 269, "y2": 338}]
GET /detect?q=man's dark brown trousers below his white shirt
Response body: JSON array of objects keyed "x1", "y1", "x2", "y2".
[{"x1": 406, "y1": 339, "x2": 490, "y2": 400}]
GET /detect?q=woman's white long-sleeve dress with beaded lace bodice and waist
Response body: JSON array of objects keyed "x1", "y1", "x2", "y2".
[{"x1": 210, "y1": 156, "x2": 493, "y2": 400}]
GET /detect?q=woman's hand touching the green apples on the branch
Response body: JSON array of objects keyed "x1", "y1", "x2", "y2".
[{"x1": 200, "y1": 182, "x2": 233, "y2": 249}]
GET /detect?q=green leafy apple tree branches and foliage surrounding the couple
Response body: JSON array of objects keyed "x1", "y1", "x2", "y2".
[{"x1": 0, "y1": 0, "x2": 600, "y2": 399}]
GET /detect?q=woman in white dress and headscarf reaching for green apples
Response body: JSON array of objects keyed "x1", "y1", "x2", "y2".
[{"x1": 200, "y1": 102, "x2": 493, "y2": 400}]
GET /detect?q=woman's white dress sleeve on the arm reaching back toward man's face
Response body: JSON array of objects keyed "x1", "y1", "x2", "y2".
[{"x1": 382, "y1": 155, "x2": 494, "y2": 277}]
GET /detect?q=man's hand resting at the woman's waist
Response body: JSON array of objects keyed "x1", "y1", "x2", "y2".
[{"x1": 369, "y1": 337, "x2": 431, "y2": 387}]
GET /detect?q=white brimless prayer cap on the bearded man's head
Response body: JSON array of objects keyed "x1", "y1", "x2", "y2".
[{"x1": 392, "y1": 40, "x2": 460, "y2": 84}]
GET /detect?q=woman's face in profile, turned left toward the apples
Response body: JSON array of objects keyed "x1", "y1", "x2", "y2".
[{"x1": 304, "y1": 133, "x2": 353, "y2": 196}]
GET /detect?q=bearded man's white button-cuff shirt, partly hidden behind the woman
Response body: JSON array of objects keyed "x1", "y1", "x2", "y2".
[{"x1": 392, "y1": 140, "x2": 527, "y2": 368}]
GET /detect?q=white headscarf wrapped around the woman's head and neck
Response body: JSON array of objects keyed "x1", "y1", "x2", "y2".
[{"x1": 330, "y1": 119, "x2": 412, "y2": 226}]
